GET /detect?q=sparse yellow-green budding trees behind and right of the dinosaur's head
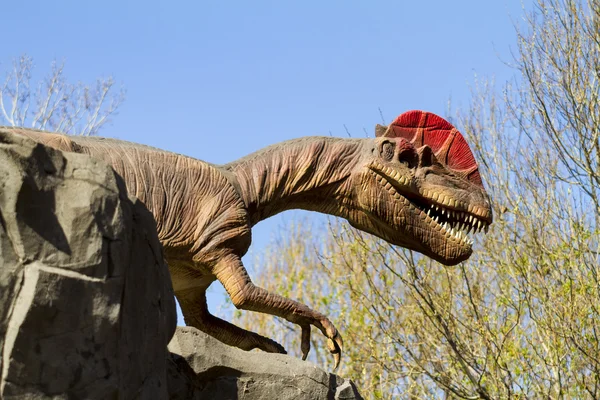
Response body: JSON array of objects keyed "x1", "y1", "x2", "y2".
[{"x1": 237, "y1": 0, "x2": 600, "y2": 399}]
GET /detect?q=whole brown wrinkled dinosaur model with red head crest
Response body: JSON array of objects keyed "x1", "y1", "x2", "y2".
[{"x1": 1, "y1": 111, "x2": 492, "y2": 368}]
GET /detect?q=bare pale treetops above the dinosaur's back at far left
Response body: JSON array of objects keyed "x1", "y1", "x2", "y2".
[{"x1": 0, "y1": 55, "x2": 125, "y2": 135}]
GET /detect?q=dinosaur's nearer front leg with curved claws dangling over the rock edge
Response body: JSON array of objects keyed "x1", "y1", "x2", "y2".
[{"x1": 213, "y1": 255, "x2": 343, "y2": 369}]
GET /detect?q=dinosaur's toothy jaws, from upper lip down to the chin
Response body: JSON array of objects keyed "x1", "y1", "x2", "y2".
[{"x1": 370, "y1": 164, "x2": 491, "y2": 265}]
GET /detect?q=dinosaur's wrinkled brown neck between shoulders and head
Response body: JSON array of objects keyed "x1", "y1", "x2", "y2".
[{"x1": 225, "y1": 137, "x2": 363, "y2": 225}]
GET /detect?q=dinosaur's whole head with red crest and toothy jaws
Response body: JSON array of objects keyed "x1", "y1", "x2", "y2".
[{"x1": 348, "y1": 111, "x2": 492, "y2": 265}]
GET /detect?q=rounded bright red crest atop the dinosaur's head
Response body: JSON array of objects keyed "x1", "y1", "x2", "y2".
[{"x1": 377, "y1": 110, "x2": 483, "y2": 187}]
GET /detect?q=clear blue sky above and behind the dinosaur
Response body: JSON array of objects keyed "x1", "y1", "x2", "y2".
[{"x1": 0, "y1": 0, "x2": 530, "y2": 322}]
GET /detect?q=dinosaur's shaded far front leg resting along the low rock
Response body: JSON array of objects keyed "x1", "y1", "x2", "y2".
[{"x1": 175, "y1": 287, "x2": 286, "y2": 354}]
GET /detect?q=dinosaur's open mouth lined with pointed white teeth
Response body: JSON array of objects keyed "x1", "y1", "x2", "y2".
[{"x1": 372, "y1": 168, "x2": 489, "y2": 248}]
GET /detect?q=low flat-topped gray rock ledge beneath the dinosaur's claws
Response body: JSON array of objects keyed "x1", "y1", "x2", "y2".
[{"x1": 168, "y1": 327, "x2": 362, "y2": 400}]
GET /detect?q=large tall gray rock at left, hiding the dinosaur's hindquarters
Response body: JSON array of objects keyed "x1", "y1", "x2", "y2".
[{"x1": 0, "y1": 130, "x2": 176, "y2": 399}]
